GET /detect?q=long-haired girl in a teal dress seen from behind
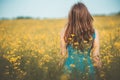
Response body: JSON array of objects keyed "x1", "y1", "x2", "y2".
[{"x1": 61, "y1": 2, "x2": 101, "y2": 80}]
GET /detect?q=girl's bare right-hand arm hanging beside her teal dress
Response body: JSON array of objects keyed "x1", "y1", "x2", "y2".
[{"x1": 92, "y1": 30, "x2": 101, "y2": 68}]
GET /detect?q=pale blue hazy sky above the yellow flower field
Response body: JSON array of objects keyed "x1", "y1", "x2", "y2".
[{"x1": 0, "y1": 0, "x2": 120, "y2": 19}]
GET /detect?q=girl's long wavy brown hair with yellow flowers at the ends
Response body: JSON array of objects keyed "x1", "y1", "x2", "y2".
[{"x1": 64, "y1": 2, "x2": 95, "y2": 50}]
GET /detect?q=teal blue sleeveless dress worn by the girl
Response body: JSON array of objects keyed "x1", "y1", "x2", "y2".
[{"x1": 64, "y1": 33, "x2": 96, "y2": 80}]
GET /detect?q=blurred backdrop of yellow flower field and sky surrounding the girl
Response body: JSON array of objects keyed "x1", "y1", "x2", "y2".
[{"x1": 0, "y1": 0, "x2": 120, "y2": 80}]
